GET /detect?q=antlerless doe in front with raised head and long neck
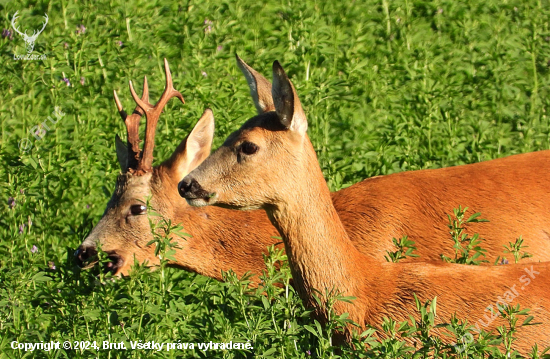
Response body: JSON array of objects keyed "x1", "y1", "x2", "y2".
[{"x1": 179, "y1": 61, "x2": 550, "y2": 354}]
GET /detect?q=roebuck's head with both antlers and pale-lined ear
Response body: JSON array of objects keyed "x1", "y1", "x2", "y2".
[{"x1": 75, "y1": 60, "x2": 214, "y2": 273}]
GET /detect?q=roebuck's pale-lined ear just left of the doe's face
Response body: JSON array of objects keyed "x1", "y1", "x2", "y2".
[{"x1": 162, "y1": 109, "x2": 214, "y2": 182}]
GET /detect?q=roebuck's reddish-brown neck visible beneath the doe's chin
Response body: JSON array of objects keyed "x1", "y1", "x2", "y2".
[{"x1": 158, "y1": 170, "x2": 277, "y2": 282}]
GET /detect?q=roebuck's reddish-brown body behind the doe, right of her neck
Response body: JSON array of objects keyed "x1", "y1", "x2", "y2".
[{"x1": 338, "y1": 150, "x2": 550, "y2": 264}]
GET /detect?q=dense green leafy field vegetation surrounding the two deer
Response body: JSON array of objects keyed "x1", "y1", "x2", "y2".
[{"x1": 0, "y1": 0, "x2": 550, "y2": 358}]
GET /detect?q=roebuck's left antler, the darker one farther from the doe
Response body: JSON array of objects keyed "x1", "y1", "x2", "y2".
[{"x1": 113, "y1": 76, "x2": 149, "y2": 170}]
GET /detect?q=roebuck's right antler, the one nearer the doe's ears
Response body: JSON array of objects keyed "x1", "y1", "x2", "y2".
[{"x1": 130, "y1": 59, "x2": 185, "y2": 175}]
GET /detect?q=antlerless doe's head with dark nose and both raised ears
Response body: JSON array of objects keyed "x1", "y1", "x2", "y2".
[{"x1": 179, "y1": 59, "x2": 310, "y2": 213}]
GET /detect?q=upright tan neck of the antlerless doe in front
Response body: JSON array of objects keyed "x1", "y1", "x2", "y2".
[{"x1": 266, "y1": 141, "x2": 385, "y2": 319}]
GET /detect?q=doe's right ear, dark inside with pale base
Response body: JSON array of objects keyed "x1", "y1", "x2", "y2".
[{"x1": 271, "y1": 61, "x2": 307, "y2": 136}]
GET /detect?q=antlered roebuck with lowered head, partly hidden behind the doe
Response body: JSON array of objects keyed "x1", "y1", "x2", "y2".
[{"x1": 76, "y1": 57, "x2": 550, "y2": 280}]
